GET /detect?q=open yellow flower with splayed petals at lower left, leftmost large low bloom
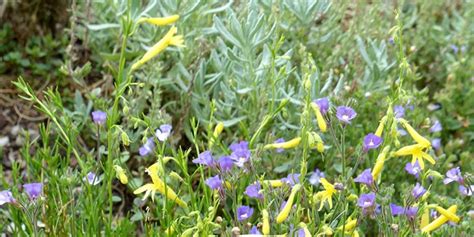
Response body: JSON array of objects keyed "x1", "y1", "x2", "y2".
[{"x1": 133, "y1": 163, "x2": 187, "y2": 207}]
